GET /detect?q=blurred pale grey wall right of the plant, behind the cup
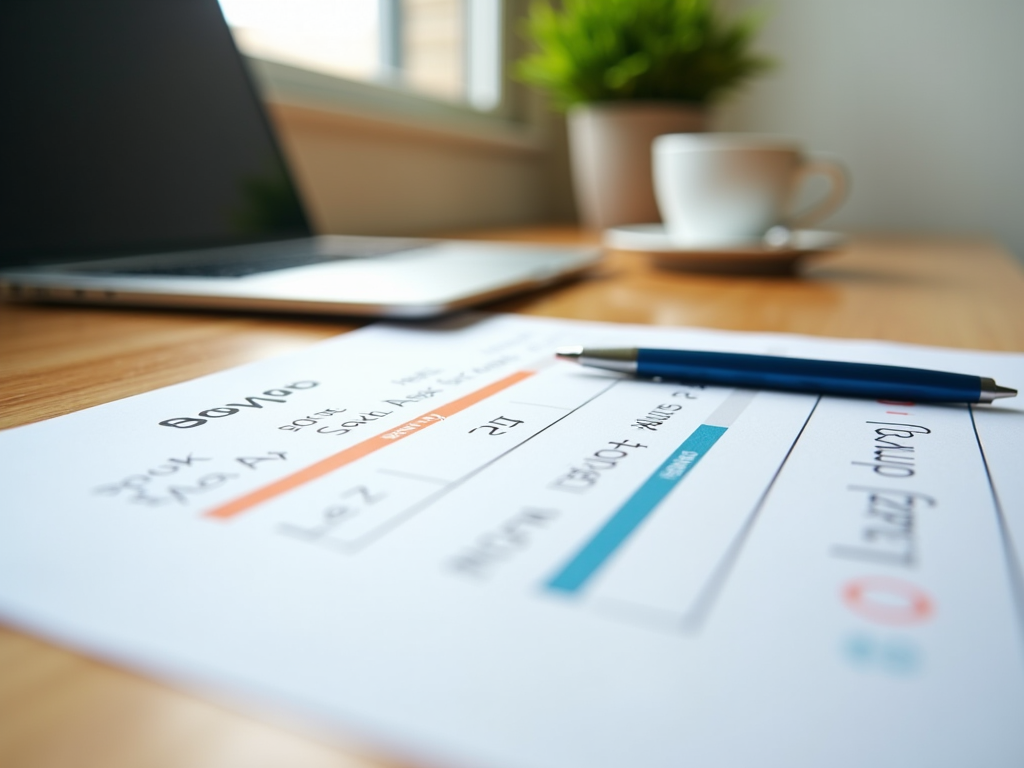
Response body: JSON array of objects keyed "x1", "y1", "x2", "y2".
[{"x1": 717, "y1": 0, "x2": 1024, "y2": 260}]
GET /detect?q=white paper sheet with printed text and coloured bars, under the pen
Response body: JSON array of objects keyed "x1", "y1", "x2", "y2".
[{"x1": 0, "y1": 316, "x2": 1024, "y2": 768}]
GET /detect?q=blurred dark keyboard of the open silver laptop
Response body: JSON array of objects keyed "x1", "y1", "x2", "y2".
[{"x1": 76, "y1": 238, "x2": 434, "y2": 278}]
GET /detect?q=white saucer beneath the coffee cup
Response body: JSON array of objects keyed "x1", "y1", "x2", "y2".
[{"x1": 604, "y1": 224, "x2": 846, "y2": 274}]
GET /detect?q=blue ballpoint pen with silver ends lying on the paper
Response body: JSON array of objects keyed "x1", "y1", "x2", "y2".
[{"x1": 555, "y1": 347, "x2": 1017, "y2": 402}]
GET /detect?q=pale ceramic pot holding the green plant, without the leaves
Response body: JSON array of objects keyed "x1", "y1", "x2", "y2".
[{"x1": 568, "y1": 101, "x2": 708, "y2": 229}]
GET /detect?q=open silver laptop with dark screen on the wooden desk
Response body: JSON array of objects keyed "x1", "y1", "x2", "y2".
[{"x1": 0, "y1": 0, "x2": 599, "y2": 317}]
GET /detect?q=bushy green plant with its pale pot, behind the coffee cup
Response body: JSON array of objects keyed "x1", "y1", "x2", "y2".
[{"x1": 517, "y1": 0, "x2": 770, "y2": 227}]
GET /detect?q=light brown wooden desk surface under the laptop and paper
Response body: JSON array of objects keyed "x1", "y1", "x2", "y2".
[{"x1": 0, "y1": 228, "x2": 1024, "y2": 768}]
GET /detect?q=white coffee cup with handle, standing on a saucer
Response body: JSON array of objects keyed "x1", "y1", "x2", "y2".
[{"x1": 652, "y1": 133, "x2": 848, "y2": 247}]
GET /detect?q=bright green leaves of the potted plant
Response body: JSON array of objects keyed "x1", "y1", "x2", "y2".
[{"x1": 516, "y1": 0, "x2": 770, "y2": 109}]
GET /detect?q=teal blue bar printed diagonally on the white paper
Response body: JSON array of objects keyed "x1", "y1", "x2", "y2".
[{"x1": 546, "y1": 424, "x2": 726, "y2": 594}]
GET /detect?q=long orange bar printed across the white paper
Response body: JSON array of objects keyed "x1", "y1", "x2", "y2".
[{"x1": 204, "y1": 371, "x2": 535, "y2": 520}]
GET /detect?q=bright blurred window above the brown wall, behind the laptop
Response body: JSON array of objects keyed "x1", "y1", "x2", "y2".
[{"x1": 220, "y1": 0, "x2": 502, "y2": 112}]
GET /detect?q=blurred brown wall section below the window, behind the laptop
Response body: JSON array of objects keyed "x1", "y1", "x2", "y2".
[{"x1": 270, "y1": 101, "x2": 572, "y2": 236}]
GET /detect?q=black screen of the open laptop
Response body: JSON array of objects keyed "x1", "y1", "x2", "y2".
[{"x1": 0, "y1": 0, "x2": 310, "y2": 266}]
